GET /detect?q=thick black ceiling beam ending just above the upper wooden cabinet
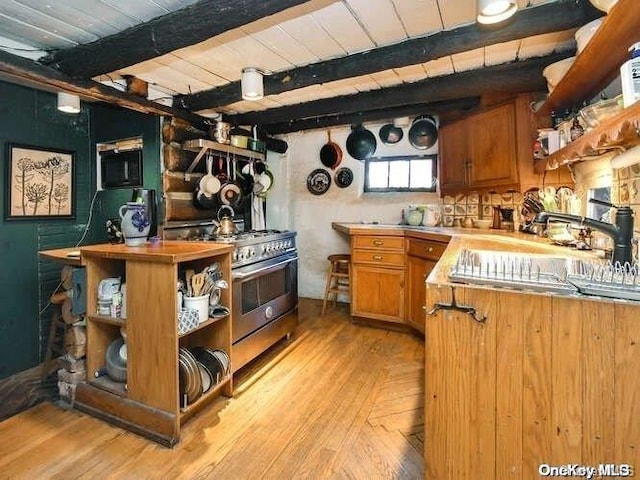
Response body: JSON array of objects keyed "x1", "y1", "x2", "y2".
[{"x1": 224, "y1": 51, "x2": 575, "y2": 131}]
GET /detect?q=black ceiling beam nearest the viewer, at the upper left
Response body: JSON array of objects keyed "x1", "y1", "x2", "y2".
[{"x1": 42, "y1": 0, "x2": 311, "y2": 78}]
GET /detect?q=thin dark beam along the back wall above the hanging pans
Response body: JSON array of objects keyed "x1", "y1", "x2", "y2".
[{"x1": 262, "y1": 97, "x2": 480, "y2": 135}]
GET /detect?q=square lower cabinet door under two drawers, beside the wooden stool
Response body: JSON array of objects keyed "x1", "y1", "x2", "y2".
[{"x1": 351, "y1": 265, "x2": 404, "y2": 322}]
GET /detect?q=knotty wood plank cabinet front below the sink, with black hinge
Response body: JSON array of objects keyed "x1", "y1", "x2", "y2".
[{"x1": 424, "y1": 285, "x2": 640, "y2": 480}]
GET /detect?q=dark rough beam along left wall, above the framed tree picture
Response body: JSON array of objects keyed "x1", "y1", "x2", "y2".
[{"x1": 0, "y1": 50, "x2": 206, "y2": 125}]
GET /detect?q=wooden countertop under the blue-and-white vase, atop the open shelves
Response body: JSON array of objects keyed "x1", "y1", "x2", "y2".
[{"x1": 80, "y1": 240, "x2": 233, "y2": 263}]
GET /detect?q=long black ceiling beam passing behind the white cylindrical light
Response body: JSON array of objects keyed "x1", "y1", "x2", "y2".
[{"x1": 179, "y1": 0, "x2": 602, "y2": 111}]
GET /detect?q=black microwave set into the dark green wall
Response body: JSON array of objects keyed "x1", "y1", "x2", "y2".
[{"x1": 100, "y1": 149, "x2": 143, "y2": 188}]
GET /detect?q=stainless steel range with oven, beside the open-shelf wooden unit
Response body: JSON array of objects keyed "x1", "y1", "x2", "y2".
[{"x1": 164, "y1": 225, "x2": 298, "y2": 372}]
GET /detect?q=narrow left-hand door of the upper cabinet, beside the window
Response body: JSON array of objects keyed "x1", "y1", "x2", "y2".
[{"x1": 438, "y1": 121, "x2": 469, "y2": 193}]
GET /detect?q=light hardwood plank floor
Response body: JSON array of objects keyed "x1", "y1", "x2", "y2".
[{"x1": 0, "y1": 299, "x2": 424, "y2": 480}]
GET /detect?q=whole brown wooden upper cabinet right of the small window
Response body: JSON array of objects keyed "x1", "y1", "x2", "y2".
[{"x1": 438, "y1": 97, "x2": 535, "y2": 194}]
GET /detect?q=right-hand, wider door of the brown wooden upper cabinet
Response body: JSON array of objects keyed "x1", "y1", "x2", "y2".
[{"x1": 468, "y1": 104, "x2": 518, "y2": 187}]
